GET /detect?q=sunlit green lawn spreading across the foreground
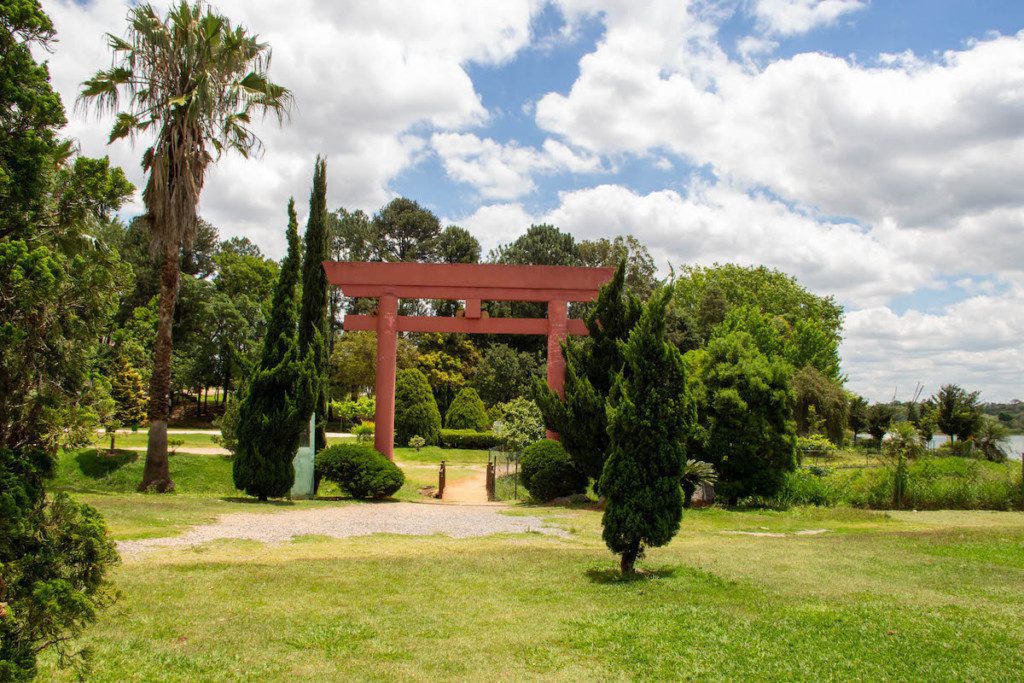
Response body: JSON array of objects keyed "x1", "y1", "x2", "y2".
[{"x1": 41, "y1": 448, "x2": 1024, "y2": 681}]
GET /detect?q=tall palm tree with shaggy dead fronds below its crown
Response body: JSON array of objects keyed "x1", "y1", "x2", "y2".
[{"x1": 79, "y1": 0, "x2": 291, "y2": 492}]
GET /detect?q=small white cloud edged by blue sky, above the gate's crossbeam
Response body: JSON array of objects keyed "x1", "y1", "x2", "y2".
[{"x1": 430, "y1": 133, "x2": 601, "y2": 200}]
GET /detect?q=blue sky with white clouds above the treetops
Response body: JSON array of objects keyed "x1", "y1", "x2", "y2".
[{"x1": 41, "y1": 0, "x2": 1024, "y2": 401}]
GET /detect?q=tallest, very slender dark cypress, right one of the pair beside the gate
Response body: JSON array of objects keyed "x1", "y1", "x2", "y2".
[{"x1": 299, "y1": 157, "x2": 330, "y2": 452}]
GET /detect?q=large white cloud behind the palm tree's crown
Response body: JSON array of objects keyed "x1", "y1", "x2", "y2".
[{"x1": 44, "y1": 0, "x2": 539, "y2": 253}]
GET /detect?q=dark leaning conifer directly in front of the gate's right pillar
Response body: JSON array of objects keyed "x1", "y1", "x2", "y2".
[{"x1": 534, "y1": 260, "x2": 642, "y2": 480}]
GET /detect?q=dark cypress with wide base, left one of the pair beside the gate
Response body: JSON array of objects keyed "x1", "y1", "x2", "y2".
[{"x1": 231, "y1": 201, "x2": 312, "y2": 501}]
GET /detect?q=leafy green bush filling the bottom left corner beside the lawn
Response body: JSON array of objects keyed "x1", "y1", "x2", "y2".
[{"x1": 0, "y1": 449, "x2": 118, "y2": 681}]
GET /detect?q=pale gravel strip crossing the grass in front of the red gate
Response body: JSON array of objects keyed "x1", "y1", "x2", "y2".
[{"x1": 118, "y1": 503, "x2": 569, "y2": 555}]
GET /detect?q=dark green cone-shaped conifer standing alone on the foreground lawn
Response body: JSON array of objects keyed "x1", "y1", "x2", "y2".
[{"x1": 600, "y1": 289, "x2": 695, "y2": 575}]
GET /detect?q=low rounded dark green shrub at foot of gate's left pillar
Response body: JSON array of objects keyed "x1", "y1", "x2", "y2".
[{"x1": 316, "y1": 443, "x2": 406, "y2": 499}]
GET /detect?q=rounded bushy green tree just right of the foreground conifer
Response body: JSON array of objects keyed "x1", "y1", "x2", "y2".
[{"x1": 688, "y1": 332, "x2": 797, "y2": 504}]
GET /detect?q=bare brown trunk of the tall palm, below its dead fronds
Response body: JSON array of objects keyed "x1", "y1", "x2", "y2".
[{"x1": 138, "y1": 240, "x2": 178, "y2": 493}]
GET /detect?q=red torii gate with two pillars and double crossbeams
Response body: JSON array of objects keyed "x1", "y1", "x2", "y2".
[{"x1": 324, "y1": 261, "x2": 614, "y2": 460}]
